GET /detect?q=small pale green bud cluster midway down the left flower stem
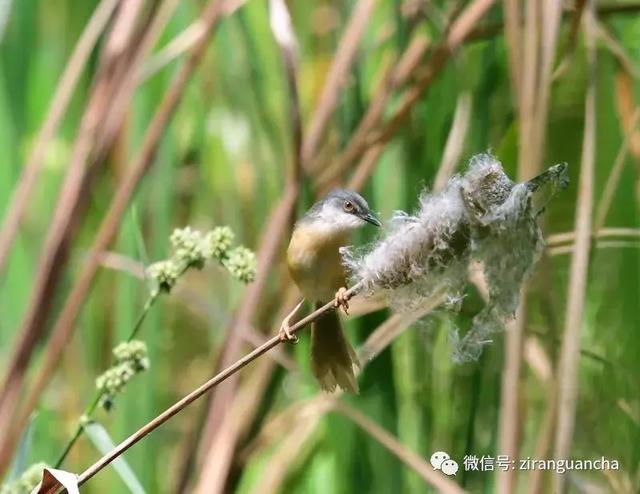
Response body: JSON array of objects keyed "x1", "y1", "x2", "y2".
[{"x1": 96, "y1": 340, "x2": 149, "y2": 410}]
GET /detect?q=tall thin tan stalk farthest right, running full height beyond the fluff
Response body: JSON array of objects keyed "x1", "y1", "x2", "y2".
[{"x1": 554, "y1": 0, "x2": 596, "y2": 494}]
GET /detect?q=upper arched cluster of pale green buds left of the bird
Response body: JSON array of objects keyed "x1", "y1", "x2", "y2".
[{"x1": 147, "y1": 226, "x2": 257, "y2": 295}]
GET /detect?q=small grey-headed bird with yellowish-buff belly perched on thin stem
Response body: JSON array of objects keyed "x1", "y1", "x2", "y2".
[{"x1": 280, "y1": 189, "x2": 381, "y2": 393}]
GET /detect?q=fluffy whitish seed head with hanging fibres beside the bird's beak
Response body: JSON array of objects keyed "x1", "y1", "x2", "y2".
[{"x1": 343, "y1": 154, "x2": 566, "y2": 361}]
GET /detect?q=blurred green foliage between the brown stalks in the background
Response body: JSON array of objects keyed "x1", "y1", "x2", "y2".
[{"x1": 0, "y1": 0, "x2": 640, "y2": 494}]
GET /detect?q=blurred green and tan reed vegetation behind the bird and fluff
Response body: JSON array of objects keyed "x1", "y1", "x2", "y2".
[{"x1": 0, "y1": 0, "x2": 640, "y2": 493}]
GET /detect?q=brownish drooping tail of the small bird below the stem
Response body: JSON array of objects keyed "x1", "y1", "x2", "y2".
[{"x1": 311, "y1": 304, "x2": 360, "y2": 393}]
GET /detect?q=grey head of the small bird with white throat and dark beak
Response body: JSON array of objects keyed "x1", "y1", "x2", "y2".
[{"x1": 301, "y1": 189, "x2": 381, "y2": 232}]
